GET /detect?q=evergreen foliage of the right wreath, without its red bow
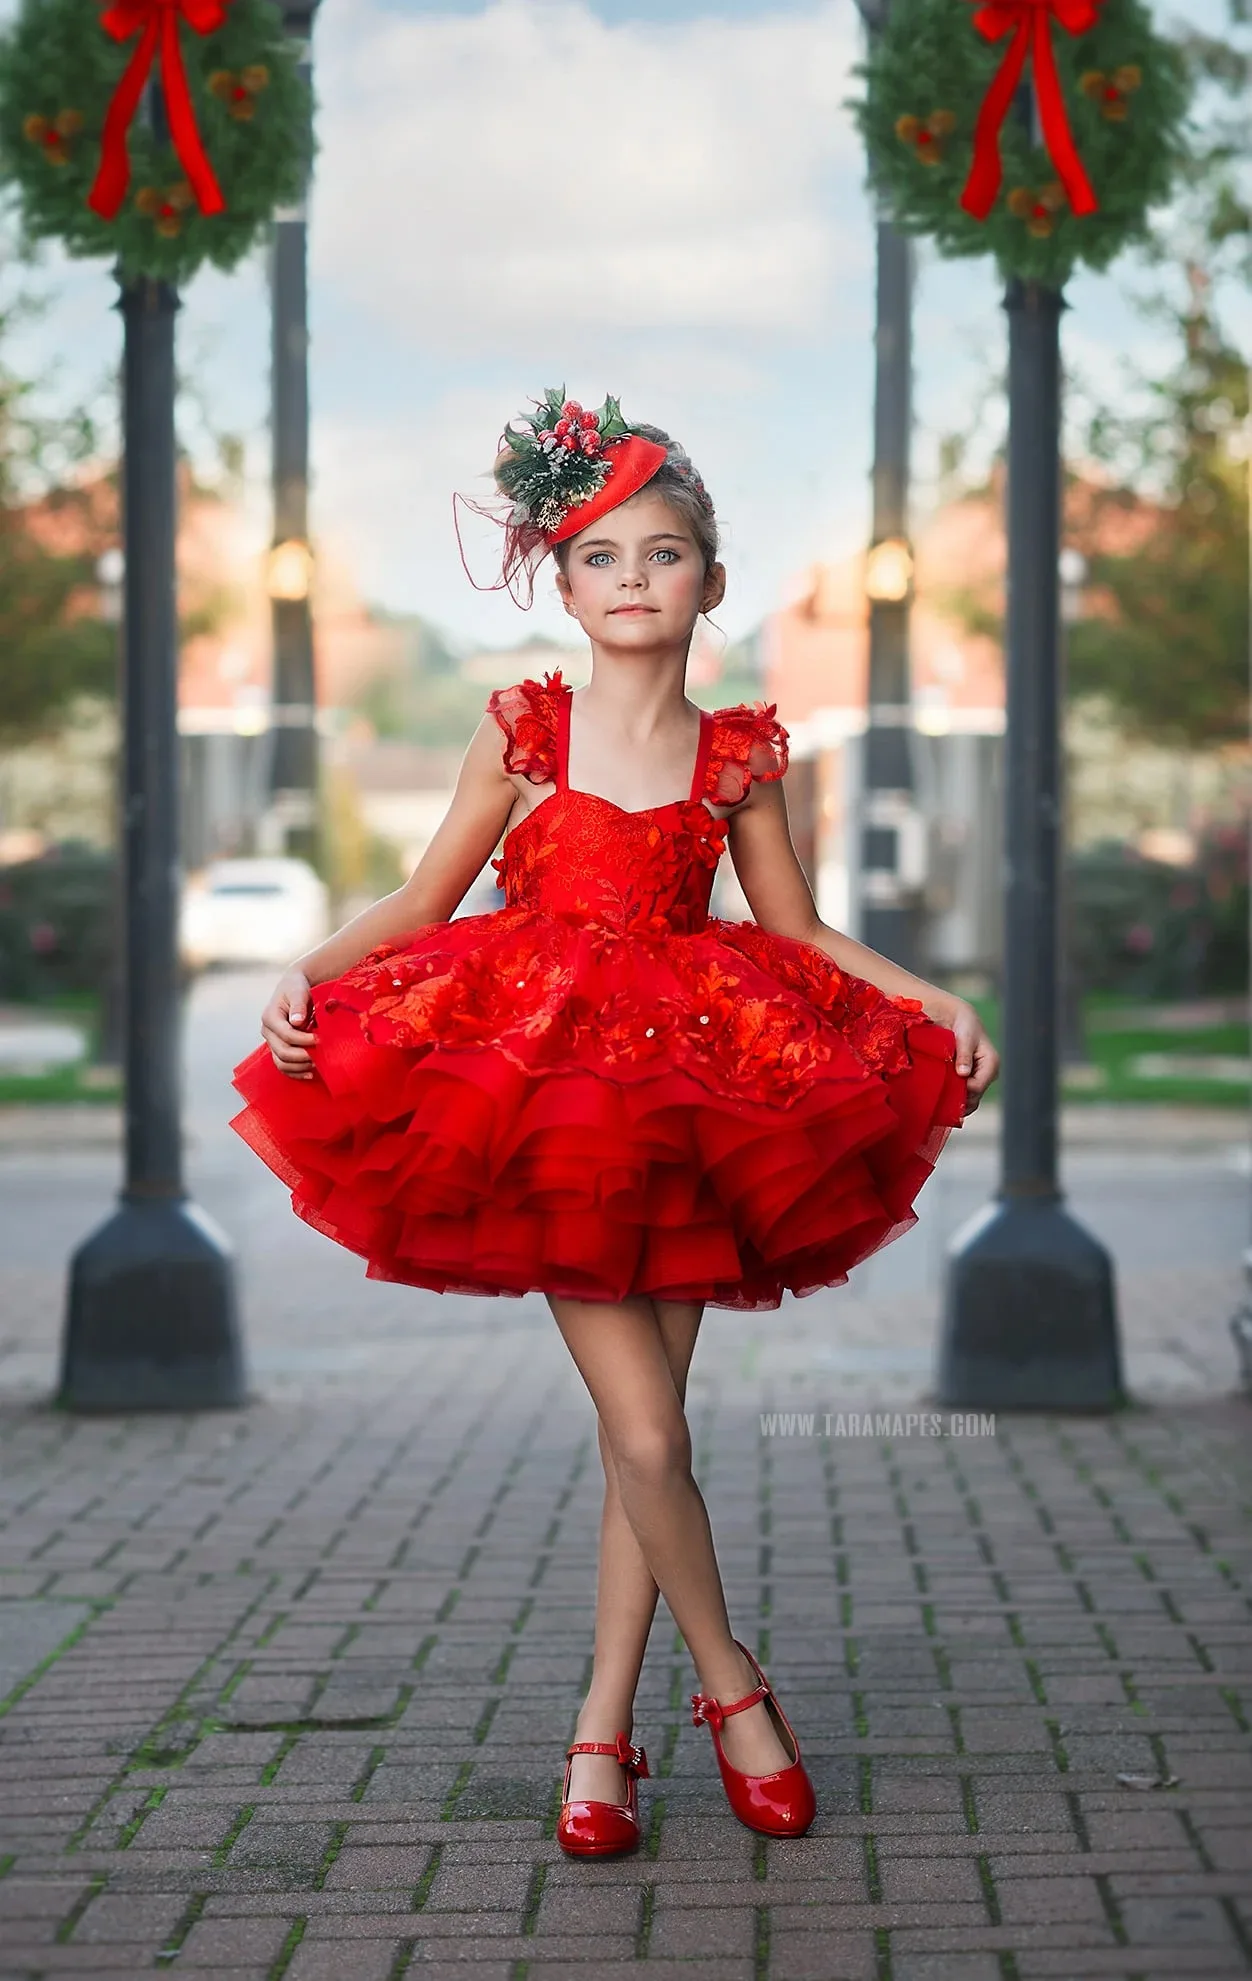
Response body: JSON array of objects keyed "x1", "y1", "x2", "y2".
[{"x1": 852, "y1": 0, "x2": 1189, "y2": 289}]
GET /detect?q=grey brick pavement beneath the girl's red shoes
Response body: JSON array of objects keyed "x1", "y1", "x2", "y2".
[{"x1": 0, "y1": 1296, "x2": 1252, "y2": 1981}]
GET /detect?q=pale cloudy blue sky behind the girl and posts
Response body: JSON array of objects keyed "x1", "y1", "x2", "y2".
[{"x1": 0, "y1": 0, "x2": 1244, "y2": 646}]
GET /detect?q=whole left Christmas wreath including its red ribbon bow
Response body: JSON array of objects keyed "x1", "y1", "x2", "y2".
[{"x1": 0, "y1": 0, "x2": 311, "y2": 281}]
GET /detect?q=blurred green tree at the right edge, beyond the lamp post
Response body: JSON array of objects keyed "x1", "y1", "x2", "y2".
[{"x1": 1070, "y1": 0, "x2": 1252, "y2": 749}]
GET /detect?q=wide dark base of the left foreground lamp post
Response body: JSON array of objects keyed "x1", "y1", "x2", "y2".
[{"x1": 55, "y1": 1197, "x2": 248, "y2": 1410}]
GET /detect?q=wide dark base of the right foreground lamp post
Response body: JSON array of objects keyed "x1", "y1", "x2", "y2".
[{"x1": 935, "y1": 1197, "x2": 1125, "y2": 1410}]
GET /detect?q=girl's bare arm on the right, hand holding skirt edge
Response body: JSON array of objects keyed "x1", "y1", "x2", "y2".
[{"x1": 729, "y1": 782, "x2": 1000, "y2": 1113}]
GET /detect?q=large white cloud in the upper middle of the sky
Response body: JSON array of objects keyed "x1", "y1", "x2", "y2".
[{"x1": 315, "y1": 0, "x2": 860, "y2": 353}]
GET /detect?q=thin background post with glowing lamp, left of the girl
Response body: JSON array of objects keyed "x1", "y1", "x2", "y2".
[{"x1": 269, "y1": 0, "x2": 317, "y2": 860}]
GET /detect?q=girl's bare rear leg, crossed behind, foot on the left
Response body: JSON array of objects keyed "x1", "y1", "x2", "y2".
[{"x1": 571, "y1": 1300, "x2": 703, "y2": 1803}]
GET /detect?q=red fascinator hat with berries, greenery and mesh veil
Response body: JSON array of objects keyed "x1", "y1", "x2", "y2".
[{"x1": 454, "y1": 386, "x2": 713, "y2": 610}]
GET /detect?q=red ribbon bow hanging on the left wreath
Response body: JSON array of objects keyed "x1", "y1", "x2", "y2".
[{"x1": 87, "y1": 0, "x2": 226, "y2": 220}]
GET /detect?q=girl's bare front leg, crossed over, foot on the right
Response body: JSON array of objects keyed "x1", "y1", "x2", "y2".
[{"x1": 549, "y1": 1298, "x2": 792, "y2": 1801}]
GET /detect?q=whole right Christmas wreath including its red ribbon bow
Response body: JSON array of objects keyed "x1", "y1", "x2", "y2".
[{"x1": 852, "y1": 0, "x2": 1187, "y2": 289}]
